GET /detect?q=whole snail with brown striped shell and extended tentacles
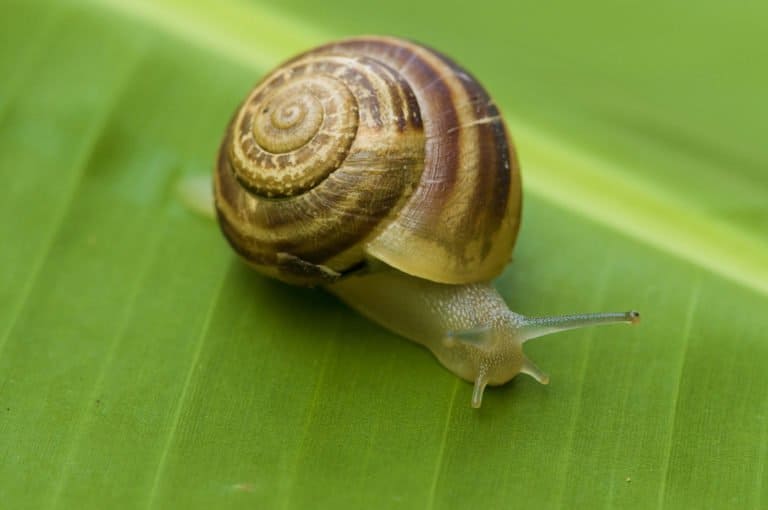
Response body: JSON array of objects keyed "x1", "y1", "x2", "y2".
[{"x1": 214, "y1": 37, "x2": 639, "y2": 408}]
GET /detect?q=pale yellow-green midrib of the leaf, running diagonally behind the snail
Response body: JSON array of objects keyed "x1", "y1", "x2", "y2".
[{"x1": 84, "y1": 0, "x2": 768, "y2": 295}]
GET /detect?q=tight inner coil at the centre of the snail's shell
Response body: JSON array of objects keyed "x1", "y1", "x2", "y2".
[{"x1": 230, "y1": 72, "x2": 358, "y2": 197}]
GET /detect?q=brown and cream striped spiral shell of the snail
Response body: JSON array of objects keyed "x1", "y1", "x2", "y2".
[{"x1": 214, "y1": 37, "x2": 521, "y2": 285}]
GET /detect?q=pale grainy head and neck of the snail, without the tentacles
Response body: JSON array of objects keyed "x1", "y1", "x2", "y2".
[{"x1": 328, "y1": 270, "x2": 525, "y2": 385}]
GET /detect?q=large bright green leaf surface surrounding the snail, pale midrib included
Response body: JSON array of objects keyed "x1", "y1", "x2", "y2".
[{"x1": 0, "y1": 0, "x2": 768, "y2": 509}]
